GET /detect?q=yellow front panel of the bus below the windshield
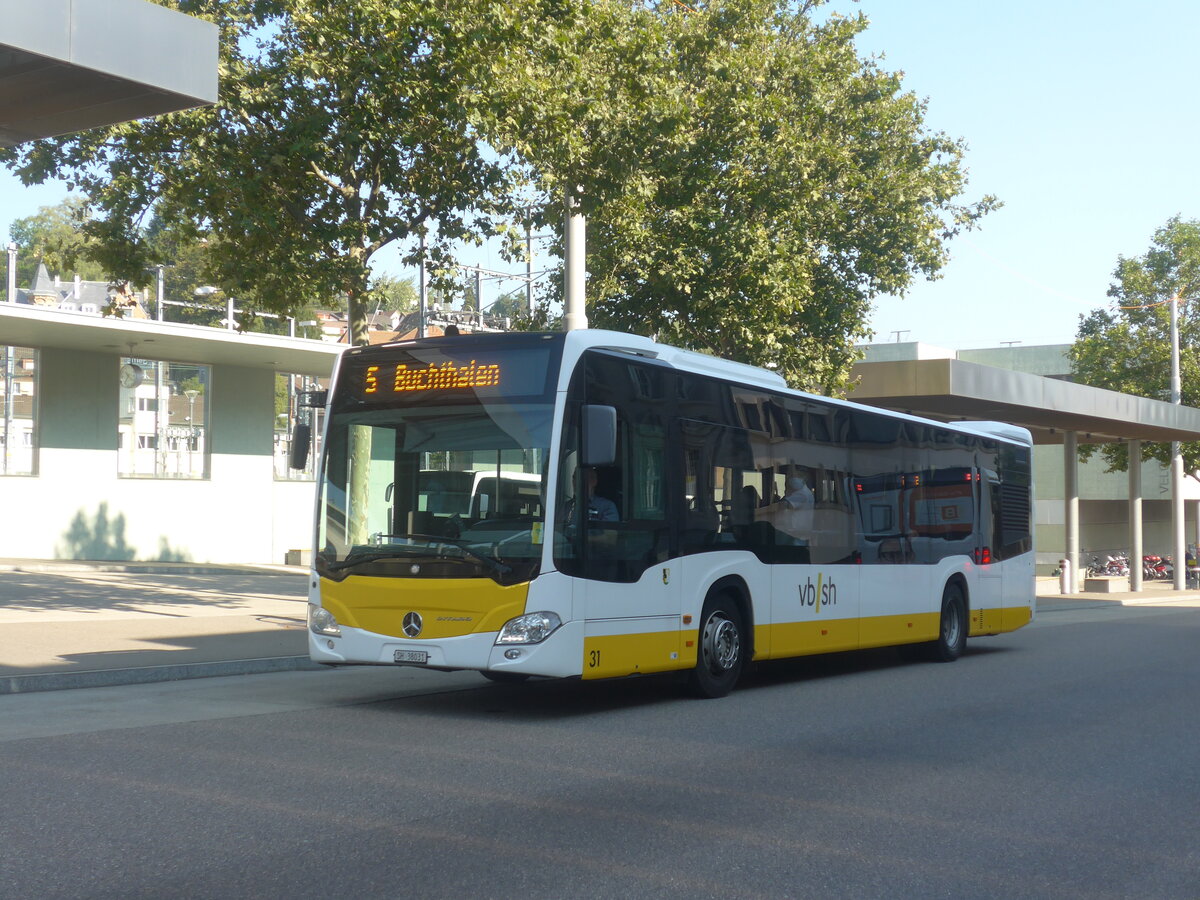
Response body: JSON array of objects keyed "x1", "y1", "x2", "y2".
[{"x1": 320, "y1": 576, "x2": 529, "y2": 641}]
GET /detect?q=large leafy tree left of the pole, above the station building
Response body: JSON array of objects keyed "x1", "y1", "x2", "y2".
[{"x1": 0, "y1": 0, "x2": 525, "y2": 343}]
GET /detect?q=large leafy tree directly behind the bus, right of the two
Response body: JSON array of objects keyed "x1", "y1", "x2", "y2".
[{"x1": 482, "y1": 0, "x2": 996, "y2": 390}]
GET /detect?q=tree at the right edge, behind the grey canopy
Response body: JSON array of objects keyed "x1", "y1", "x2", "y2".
[{"x1": 1070, "y1": 216, "x2": 1200, "y2": 472}]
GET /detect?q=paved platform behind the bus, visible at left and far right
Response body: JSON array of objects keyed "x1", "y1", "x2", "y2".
[{"x1": 0, "y1": 559, "x2": 1200, "y2": 694}]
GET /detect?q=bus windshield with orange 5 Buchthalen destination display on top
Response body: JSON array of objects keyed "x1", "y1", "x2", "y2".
[{"x1": 317, "y1": 342, "x2": 553, "y2": 583}]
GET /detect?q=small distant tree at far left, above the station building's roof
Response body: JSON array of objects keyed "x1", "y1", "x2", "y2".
[{"x1": 8, "y1": 196, "x2": 108, "y2": 287}]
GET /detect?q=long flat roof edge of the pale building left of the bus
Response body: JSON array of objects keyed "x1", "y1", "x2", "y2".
[{"x1": 0, "y1": 302, "x2": 346, "y2": 378}]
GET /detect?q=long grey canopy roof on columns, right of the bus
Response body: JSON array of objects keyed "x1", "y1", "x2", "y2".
[{"x1": 848, "y1": 359, "x2": 1200, "y2": 444}]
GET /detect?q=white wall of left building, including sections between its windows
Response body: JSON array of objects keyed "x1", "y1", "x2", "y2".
[{"x1": 0, "y1": 349, "x2": 313, "y2": 564}]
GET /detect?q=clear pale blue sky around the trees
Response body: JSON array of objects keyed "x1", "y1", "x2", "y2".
[{"x1": 0, "y1": 0, "x2": 1200, "y2": 349}]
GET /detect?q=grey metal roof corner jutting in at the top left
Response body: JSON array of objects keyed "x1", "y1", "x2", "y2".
[{"x1": 0, "y1": 0, "x2": 218, "y2": 146}]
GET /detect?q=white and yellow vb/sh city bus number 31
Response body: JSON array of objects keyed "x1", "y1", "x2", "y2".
[{"x1": 300, "y1": 329, "x2": 1034, "y2": 697}]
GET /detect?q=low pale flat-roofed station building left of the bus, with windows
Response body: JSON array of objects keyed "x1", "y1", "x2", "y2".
[{"x1": 0, "y1": 302, "x2": 341, "y2": 564}]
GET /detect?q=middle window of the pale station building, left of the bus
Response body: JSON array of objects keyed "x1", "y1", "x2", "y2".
[{"x1": 116, "y1": 358, "x2": 212, "y2": 479}]
